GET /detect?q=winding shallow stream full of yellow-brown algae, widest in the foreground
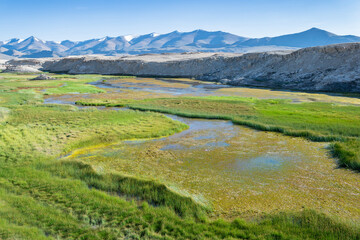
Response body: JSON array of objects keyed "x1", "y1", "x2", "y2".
[{"x1": 45, "y1": 77, "x2": 360, "y2": 219}]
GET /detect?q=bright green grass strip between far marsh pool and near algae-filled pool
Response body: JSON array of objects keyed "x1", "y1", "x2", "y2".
[{"x1": 125, "y1": 97, "x2": 360, "y2": 169}]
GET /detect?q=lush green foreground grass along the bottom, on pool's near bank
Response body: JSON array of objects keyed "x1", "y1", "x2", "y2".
[{"x1": 0, "y1": 162, "x2": 360, "y2": 239}]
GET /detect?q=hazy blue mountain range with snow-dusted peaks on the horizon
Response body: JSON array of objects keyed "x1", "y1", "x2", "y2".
[{"x1": 0, "y1": 28, "x2": 360, "y2": 58}]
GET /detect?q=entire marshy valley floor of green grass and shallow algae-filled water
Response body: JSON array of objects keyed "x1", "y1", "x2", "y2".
[{"x1": 0, "y1": 73, "x2": 360, "y2": 239}]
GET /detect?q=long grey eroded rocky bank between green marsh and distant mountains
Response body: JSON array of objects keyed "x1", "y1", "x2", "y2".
[{"x1": 4, "y1": 43, "x2": 360, "y2": 93}]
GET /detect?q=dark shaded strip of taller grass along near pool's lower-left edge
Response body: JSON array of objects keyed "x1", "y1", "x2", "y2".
[{"x1": 44, "y1": 160, "x2": 210, "y2": 220}]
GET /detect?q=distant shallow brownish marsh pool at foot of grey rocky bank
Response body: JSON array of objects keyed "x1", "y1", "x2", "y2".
[{"x1": 91, "y1": 78, "x2": 360, "y2": 105}]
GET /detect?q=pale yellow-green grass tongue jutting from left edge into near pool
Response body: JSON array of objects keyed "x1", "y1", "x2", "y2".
[{"x1": 0, "y1": 105, "x2": 187, "y2": 162}]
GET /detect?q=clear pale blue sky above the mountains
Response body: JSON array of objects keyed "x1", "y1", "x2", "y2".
[{"x1": 0, "y1": 0, "x2": 360, "y2": 41}]
